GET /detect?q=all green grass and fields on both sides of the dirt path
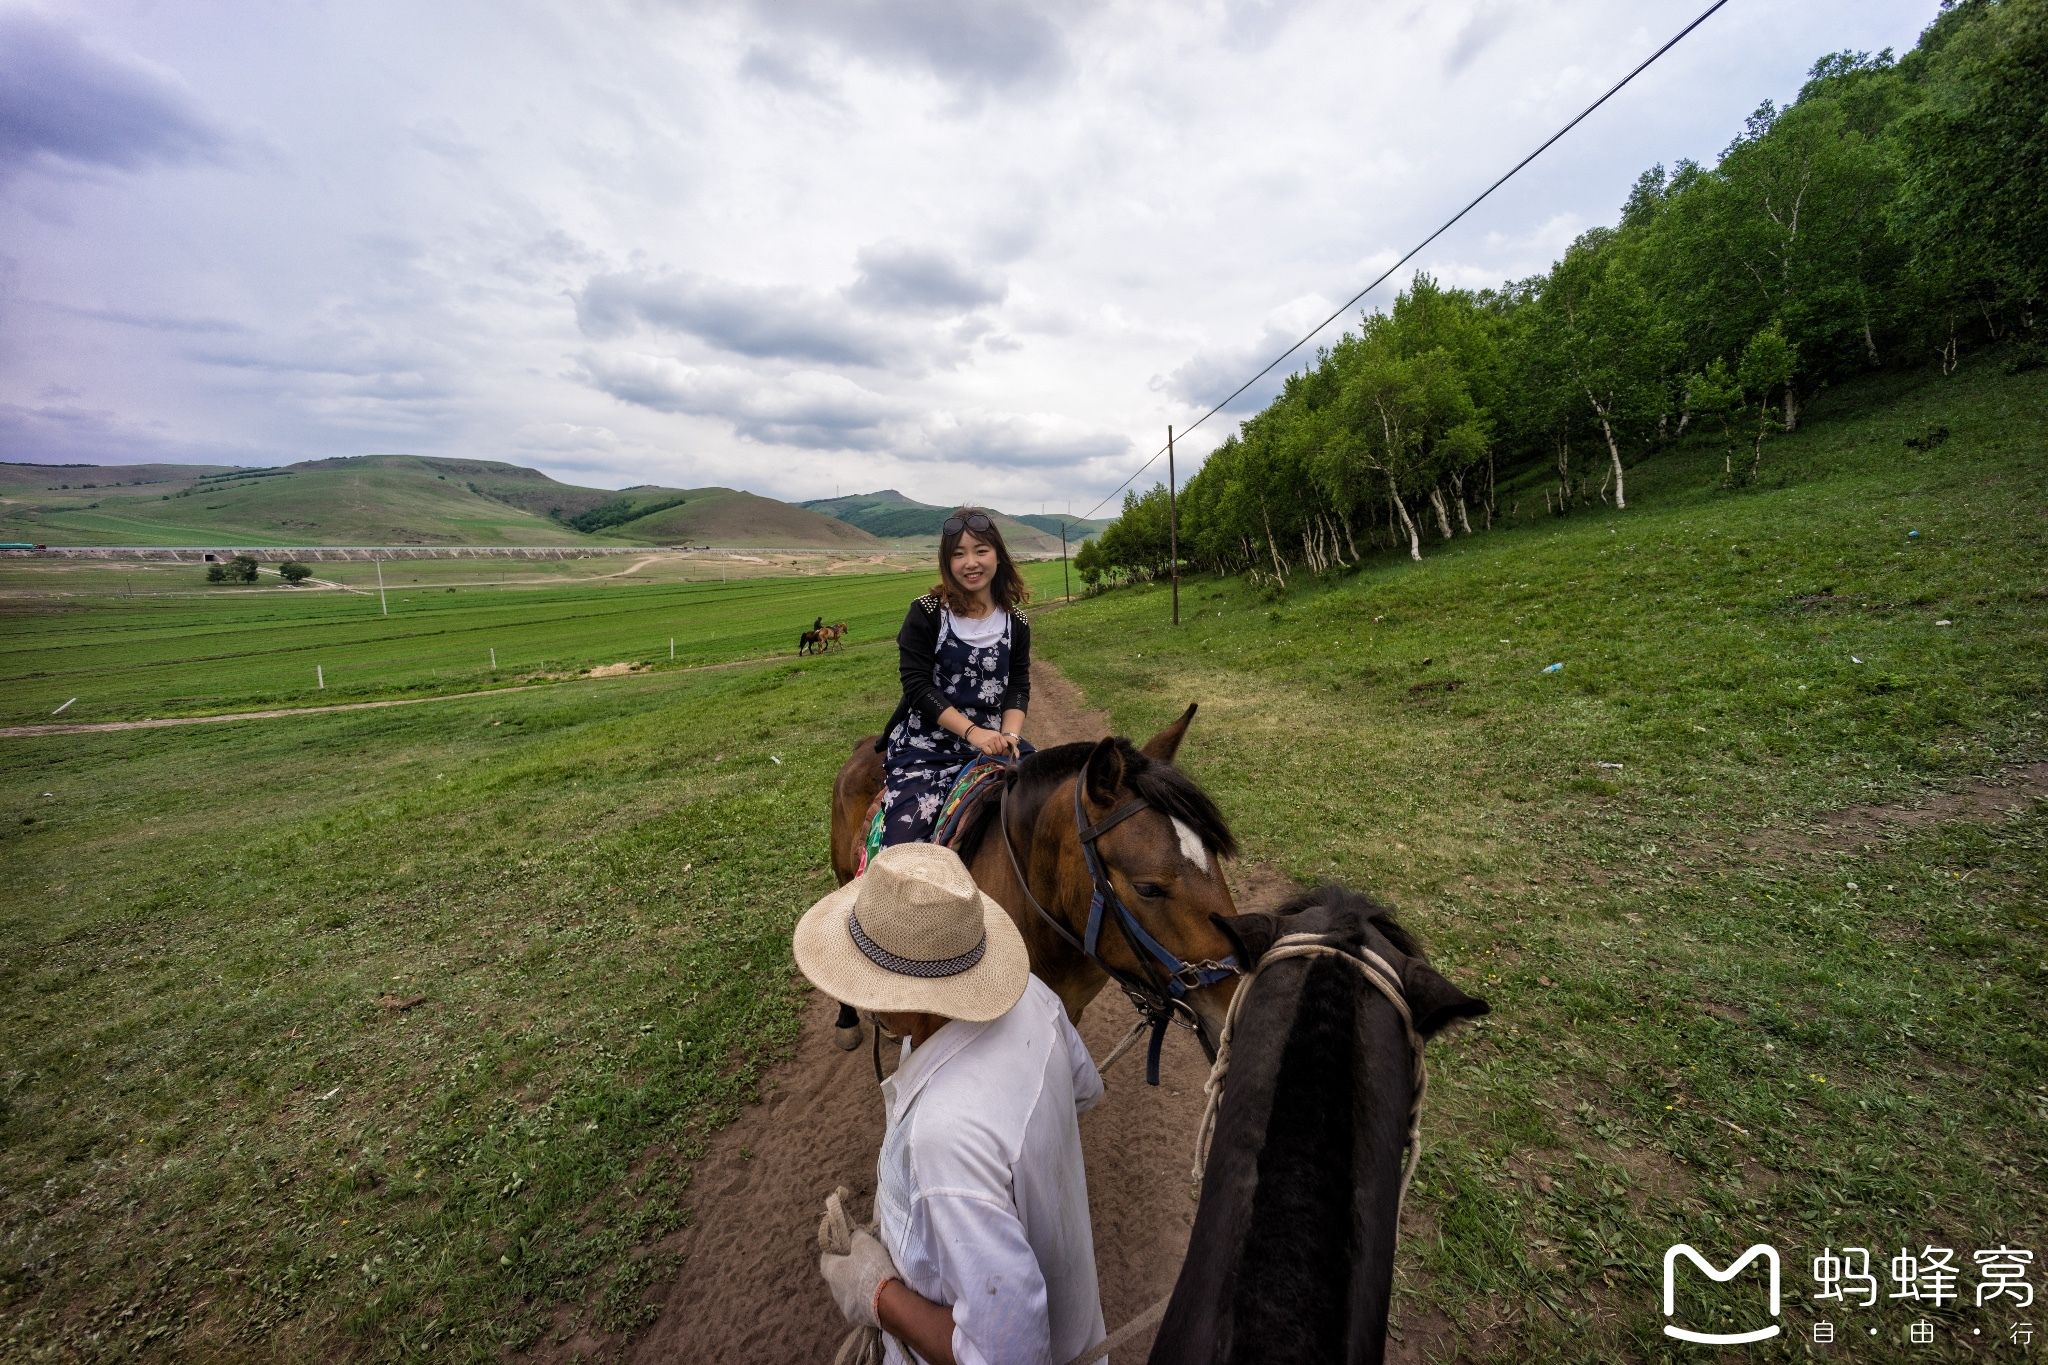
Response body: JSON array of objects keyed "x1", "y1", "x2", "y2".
[{"x1": 0, "y1": 366, "x2": 2048, "y2": 1361}]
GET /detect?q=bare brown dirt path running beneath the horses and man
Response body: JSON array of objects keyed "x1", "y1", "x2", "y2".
[{"x1": 535, "y1": 663, "x2": 1292, "y2": 1363}]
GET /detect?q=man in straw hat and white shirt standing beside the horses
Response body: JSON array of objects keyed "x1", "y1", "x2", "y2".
[{"x1": 795, "y1": 843, "x2": 1104, "y2": 1365}]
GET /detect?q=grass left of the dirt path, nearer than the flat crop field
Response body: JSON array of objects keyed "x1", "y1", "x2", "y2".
[{"x1": 0, "y1": 653, "x2": 893, "y2": 1361}]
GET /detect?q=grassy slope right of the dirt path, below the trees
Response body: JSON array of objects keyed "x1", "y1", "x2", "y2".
[{"x1": 1040, "y1": 364, "x2": 2048, "y2": 1361}]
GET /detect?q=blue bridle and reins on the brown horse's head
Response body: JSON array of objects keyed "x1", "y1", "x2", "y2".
[{"x1": 995, "y1": 778, "x2": 1243, "y2": 1085}]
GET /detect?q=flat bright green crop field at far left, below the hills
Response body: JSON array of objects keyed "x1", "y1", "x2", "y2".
[{"x1": 0, "y1": 561, "x2": 1059, "y2": 724}]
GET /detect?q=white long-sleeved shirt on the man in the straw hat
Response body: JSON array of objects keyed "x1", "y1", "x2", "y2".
[{"x1": 874, "y1": 976, "x2": 1106, "y2": 1365}]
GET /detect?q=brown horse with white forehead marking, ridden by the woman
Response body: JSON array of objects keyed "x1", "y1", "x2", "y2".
[{"x1": 831, "y1": 706, "x2": 1237, "y2": 1060}]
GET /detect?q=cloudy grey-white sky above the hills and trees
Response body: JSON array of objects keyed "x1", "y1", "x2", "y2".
[{"x1": 0, "y1": 0, "x2": 1935, "y2": 514}]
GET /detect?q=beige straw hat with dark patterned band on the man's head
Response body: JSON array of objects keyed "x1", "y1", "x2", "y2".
[{"x1": 795, "y1": 843, "x2": 1030, "y2": 1023}]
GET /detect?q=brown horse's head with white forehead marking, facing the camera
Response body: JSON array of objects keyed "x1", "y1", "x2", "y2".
[{"x1": 1067, "y1": 706, "x2": 1237, "y2": 1058}]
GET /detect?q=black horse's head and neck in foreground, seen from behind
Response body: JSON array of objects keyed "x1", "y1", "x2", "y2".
[{"x1": 1151, "y1": 886, "x2": 1487, "y2": 1365}]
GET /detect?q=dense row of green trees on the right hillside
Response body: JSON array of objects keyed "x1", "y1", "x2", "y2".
[{"x1": 1075, "y1": 0, "x2": 2048, "y2": 585}]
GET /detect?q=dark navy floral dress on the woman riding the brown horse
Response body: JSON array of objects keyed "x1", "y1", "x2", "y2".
[{"x1": 883, "y1": 612, "x2": 1010, "y2": 847}]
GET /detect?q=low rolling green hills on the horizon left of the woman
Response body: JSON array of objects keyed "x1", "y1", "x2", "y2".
[{"x1": 0, "y1": 454, "x2": 885, "y2": 551}]
